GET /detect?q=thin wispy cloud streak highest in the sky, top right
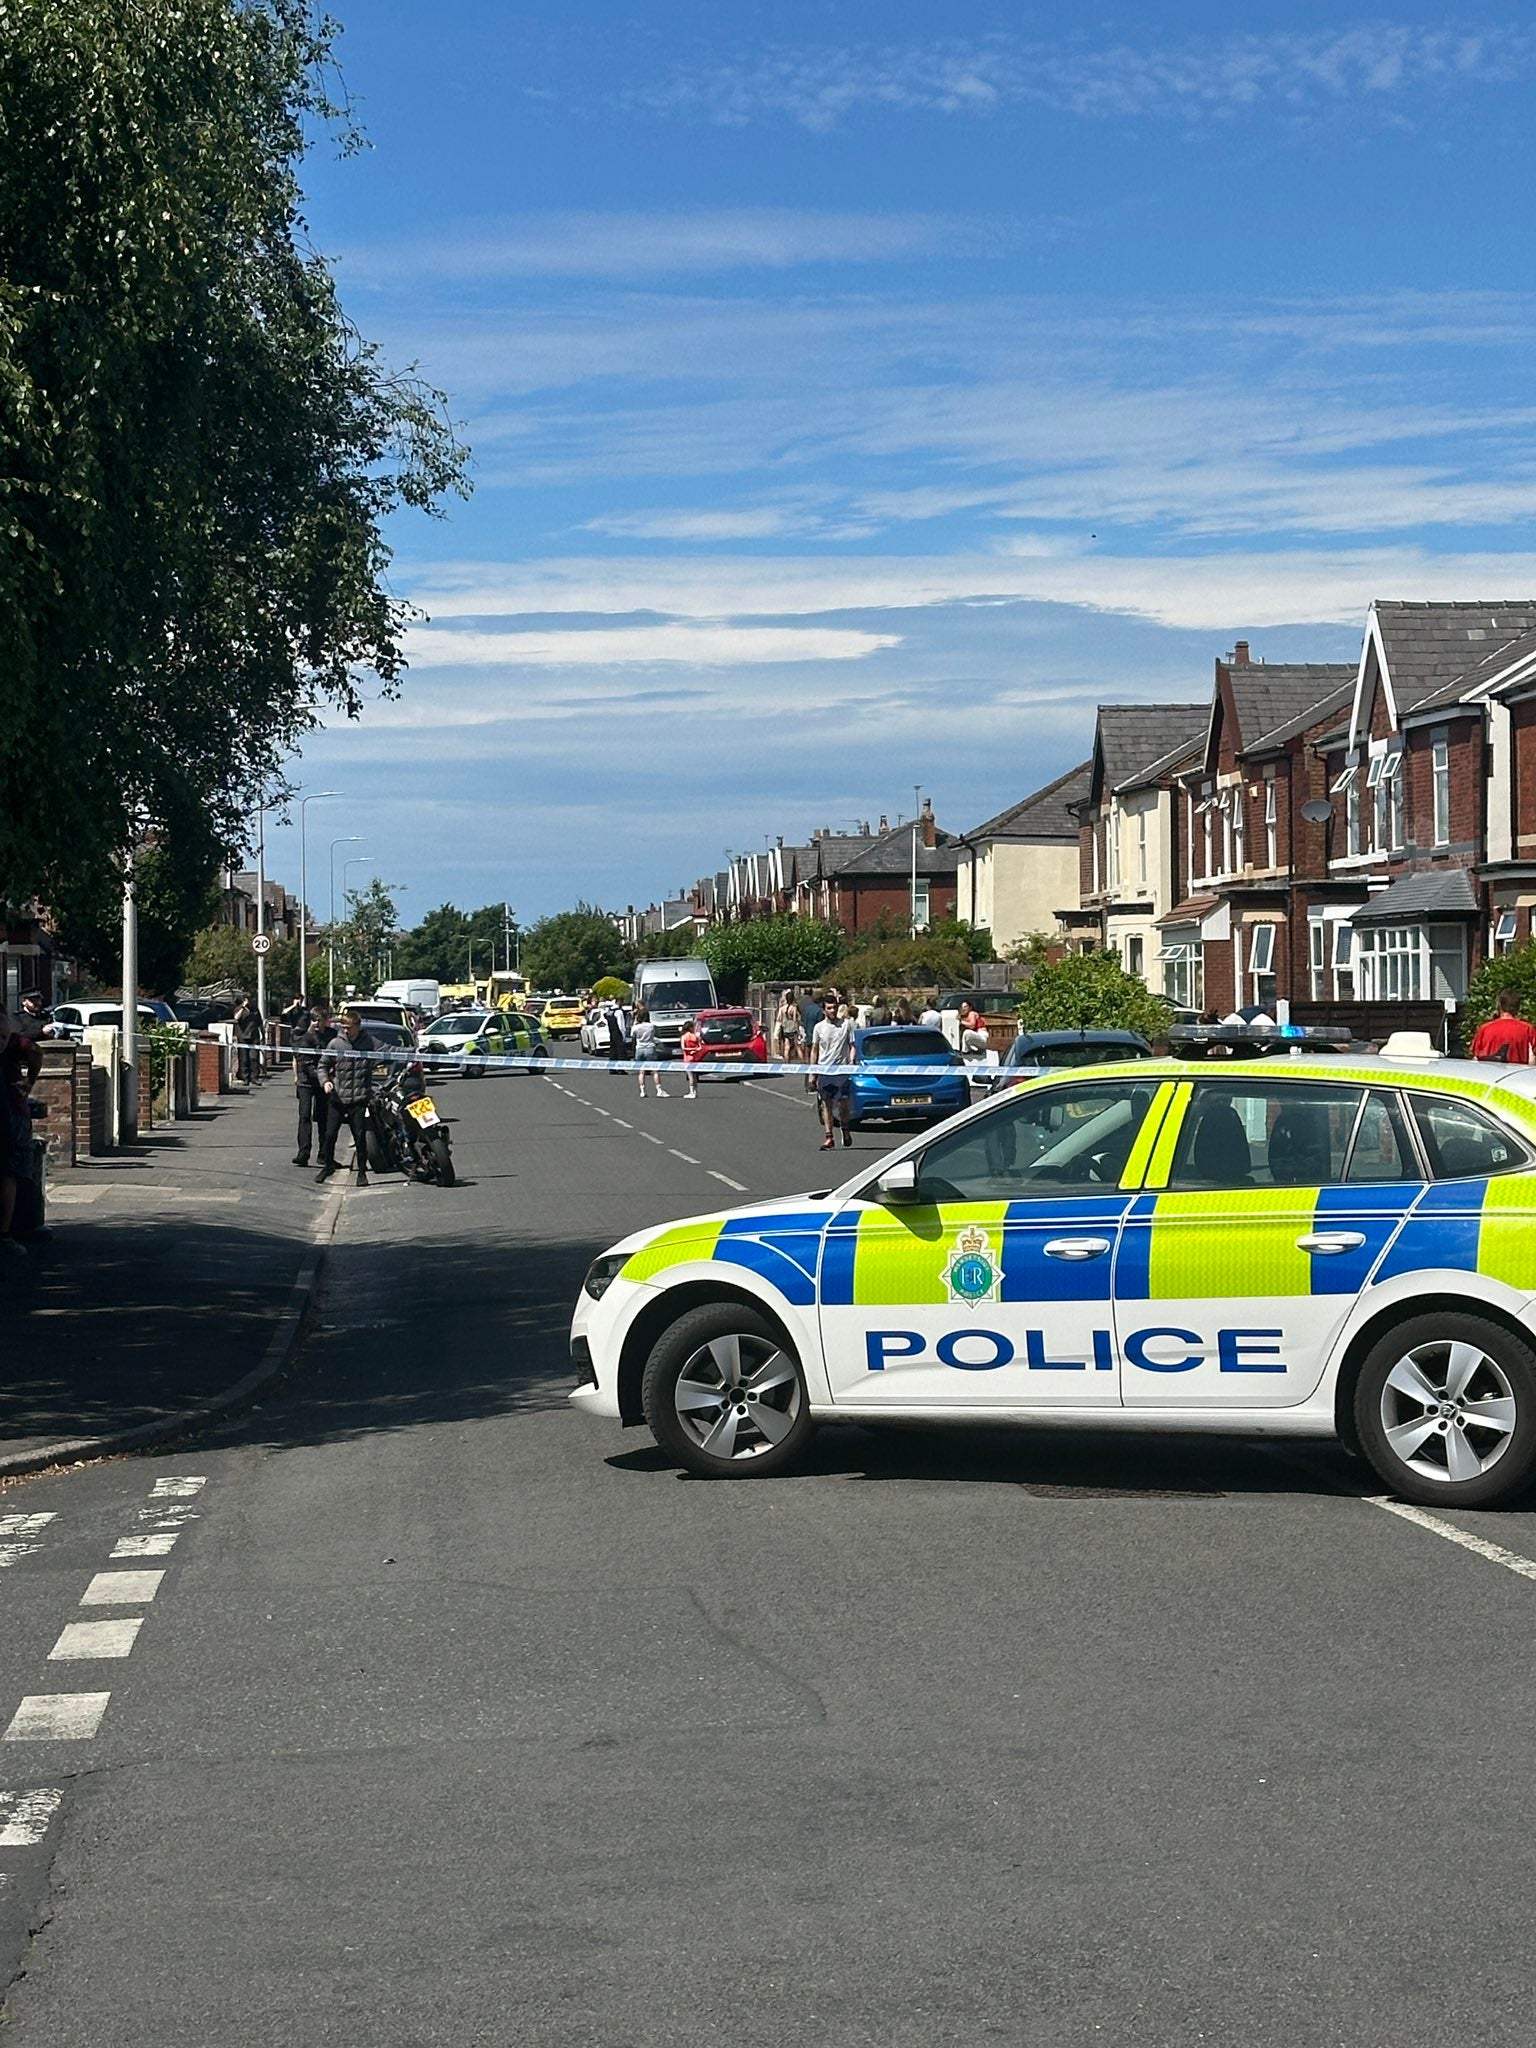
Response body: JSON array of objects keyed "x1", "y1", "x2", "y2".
[{"x1": 627, "y1": 20, "x2": 1536, "y2": 131}]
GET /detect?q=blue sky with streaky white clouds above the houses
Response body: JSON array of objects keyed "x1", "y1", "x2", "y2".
[{"x1": 272, "y1": 0, "x2": 1536, "y2": 922}]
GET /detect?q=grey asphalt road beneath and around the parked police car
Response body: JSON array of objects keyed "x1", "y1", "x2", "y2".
[{"x1": 0, "y1": 1071, "x2": 1536, "y2": 2048}]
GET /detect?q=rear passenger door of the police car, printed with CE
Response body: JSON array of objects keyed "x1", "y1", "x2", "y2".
[{"x1": 1114, "y1": 1073, "x2": 1421, "y2": 1407}]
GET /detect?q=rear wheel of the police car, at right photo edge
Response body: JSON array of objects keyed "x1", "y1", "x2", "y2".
[{"x1": 1354, "y1": 1315, "x2": 1536, "y2": 1507}]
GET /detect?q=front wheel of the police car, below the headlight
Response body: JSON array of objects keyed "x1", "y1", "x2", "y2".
[{"x1": 643, "y1": 1303, "x2": 811, "y2": 1479}]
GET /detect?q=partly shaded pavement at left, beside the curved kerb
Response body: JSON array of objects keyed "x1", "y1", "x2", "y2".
[{"x1": 0, "y1": 1075, "x2": 336, "y2": 1475}]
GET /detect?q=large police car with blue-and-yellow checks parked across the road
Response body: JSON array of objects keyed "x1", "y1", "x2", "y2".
[{"x1": 571, "y1": 1051, "x2": 1536, "y2": 1507}]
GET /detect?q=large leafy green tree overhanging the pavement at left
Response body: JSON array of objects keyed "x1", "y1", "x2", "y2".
[{"x1": 0, "y1": 0, "x2": 463, "y2": 899}]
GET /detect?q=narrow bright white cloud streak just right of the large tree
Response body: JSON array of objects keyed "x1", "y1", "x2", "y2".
[{"x1": 406, "y1": 606, "x2": 901, "y2": 668}]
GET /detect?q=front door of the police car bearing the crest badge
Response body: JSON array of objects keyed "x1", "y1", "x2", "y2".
[{"x1": 819, "y1": 1079, "x2": 1174, "y2": 1407}]
